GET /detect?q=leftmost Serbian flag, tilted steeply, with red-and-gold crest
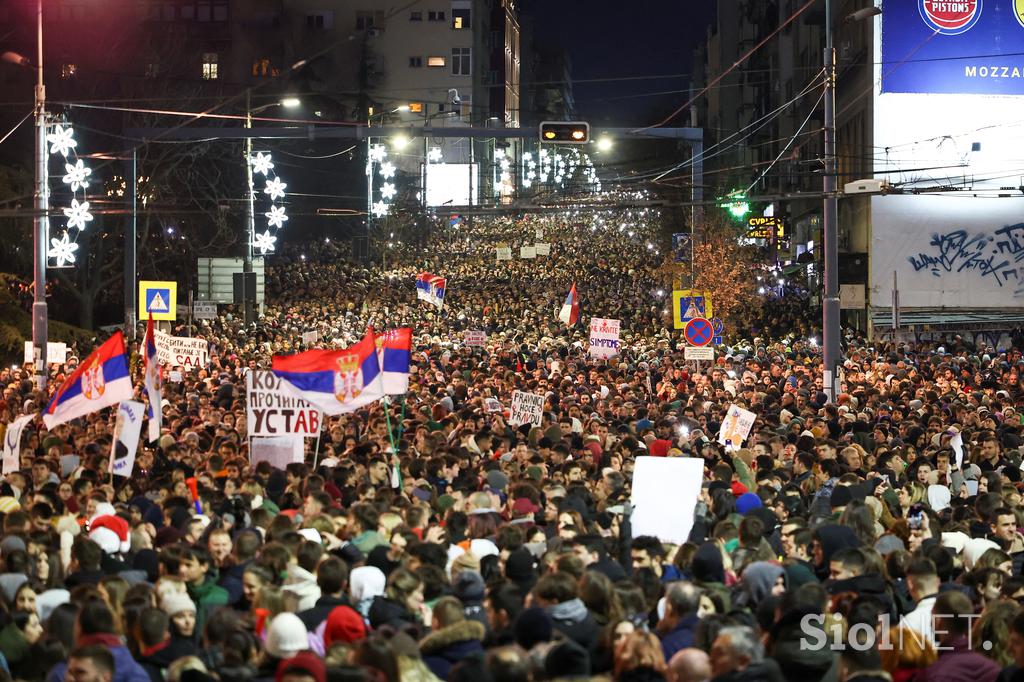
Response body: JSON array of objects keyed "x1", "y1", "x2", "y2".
[{"x1": 43, "y1": 332, "x2": 132, "y2": 429}]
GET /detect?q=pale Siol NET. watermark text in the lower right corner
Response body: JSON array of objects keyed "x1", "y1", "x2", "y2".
[{"x1": 800, "y1": 613, "x2": 992, "y2": 651}]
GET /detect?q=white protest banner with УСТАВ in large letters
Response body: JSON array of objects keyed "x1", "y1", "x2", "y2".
[{"x1": 246, "y1": 370, "x2": 321, "y2": 436}]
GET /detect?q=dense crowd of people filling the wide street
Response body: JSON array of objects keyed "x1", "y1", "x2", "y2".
[{"x1": 0, "y1": 206, "x2": 1024, "y2": 682}]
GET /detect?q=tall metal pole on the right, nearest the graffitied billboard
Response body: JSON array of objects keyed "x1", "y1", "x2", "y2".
[{"x1": 821, "y1": 0, "x2": 840, "y2": 402}]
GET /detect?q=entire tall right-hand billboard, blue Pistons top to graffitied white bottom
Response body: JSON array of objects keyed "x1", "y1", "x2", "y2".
[{"x1": 865, "y1": 0, "x2": 1024, "y2": 310}]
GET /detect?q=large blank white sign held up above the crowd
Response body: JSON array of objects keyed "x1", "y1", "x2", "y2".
[{"x1": 630, "y1": 457, "x2": 703, "y2": 545}]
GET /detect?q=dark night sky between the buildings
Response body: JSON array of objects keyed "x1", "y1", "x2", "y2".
[{"x1": 519, "y1": 0, "x2": 716, "y2": 125}]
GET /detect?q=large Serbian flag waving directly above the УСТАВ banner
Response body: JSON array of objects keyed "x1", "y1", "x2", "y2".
[{"x1": 271, "y1": 328, "x2": 384, "y2": 415}]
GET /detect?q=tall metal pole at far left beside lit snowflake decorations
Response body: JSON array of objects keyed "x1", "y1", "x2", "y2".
[{"x1": 32, "y1": 0, "x2": 50, "y2": 390}]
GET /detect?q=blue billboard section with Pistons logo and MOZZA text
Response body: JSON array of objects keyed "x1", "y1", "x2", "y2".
[{"x1": 881, "y1": 0, "x2": 1024, "y2": 95}]
